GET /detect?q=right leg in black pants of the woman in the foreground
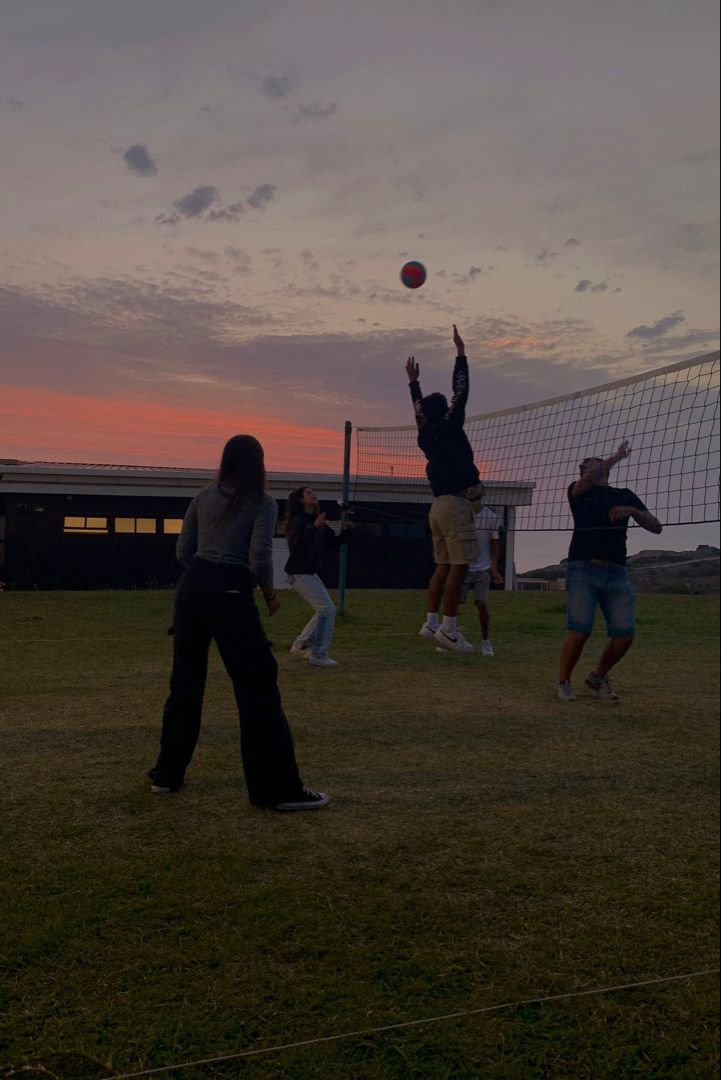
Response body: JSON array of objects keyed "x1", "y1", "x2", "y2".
[{"x1": 210, "y1": 584, "x2": 302, "y2": 806}]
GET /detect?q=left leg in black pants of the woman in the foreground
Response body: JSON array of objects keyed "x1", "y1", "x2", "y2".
[{"x1": 149, "y1": 575, "x2": 210, "y2": 791}]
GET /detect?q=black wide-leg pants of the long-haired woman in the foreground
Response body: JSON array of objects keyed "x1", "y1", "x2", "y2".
[{"x1": 150, "y1": 557, "x2": 302, "y2": 806}]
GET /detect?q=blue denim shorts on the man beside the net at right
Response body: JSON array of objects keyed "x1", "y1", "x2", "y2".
[{"x1": 566, "y1": 559, "x2": 636, "y2": 637}]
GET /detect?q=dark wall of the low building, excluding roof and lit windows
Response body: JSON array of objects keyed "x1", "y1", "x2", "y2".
[{"x1": 0, "y1": 492, "x2": 504, "y2": 589}]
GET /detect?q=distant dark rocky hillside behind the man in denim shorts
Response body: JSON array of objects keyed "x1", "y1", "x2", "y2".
[{"x1": 518, "y1": 544, "x2": 721, "y2": 596}]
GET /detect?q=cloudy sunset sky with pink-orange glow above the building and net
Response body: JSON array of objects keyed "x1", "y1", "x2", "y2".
[{"x1": 0, "y1": 0, "x2": 719, "y2": 570}]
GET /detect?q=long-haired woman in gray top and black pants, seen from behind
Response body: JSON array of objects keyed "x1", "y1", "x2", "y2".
[{"x1": 149, "y1": 435, "x2": 330, "y2": 810}]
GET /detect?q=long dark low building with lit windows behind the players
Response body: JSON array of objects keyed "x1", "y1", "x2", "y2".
[{"x1": 0, "y1": 459, "x2": 533, "y2": 589}]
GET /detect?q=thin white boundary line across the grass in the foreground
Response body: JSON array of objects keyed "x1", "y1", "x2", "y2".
[{"x1": 103, "y1": 968, "x2": 721, "y2": 1080}]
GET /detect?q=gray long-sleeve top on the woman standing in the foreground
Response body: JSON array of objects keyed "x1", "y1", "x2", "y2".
[{"x1": 176, "y1": 484, "x2": 277, "y2": 592}]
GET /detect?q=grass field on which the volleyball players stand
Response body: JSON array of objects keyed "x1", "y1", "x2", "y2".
[{"x1": 0, "y1": 592, "x2": 719, "y2": 1080}]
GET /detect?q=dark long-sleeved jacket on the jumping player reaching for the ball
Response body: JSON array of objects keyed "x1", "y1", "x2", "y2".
[{"x1": 409, "y1": 356, "x2": 478, "y2": 496}]
